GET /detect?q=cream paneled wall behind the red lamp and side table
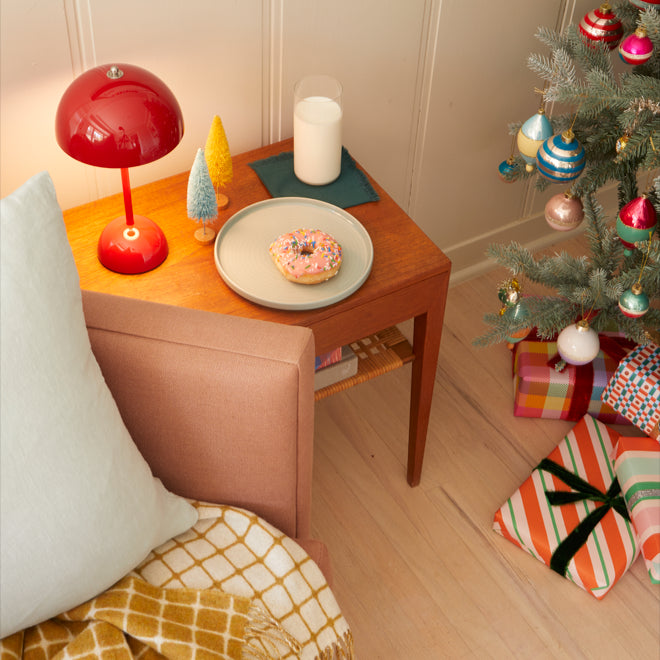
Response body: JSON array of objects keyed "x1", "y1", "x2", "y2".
[{"x1": 0, "y1": 0, "x2": 598, "y2": 279}]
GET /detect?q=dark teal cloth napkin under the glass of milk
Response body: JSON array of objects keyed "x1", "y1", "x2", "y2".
[{"x1": 249, "y1": 147, "x2": 380, "y2": 209}]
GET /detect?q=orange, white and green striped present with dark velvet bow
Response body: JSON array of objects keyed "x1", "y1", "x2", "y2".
[{"x1": 493, "y1": 415, "x2": 639, "y2": 599}]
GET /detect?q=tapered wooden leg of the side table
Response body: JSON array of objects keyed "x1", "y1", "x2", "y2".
[{"x1": 407, "y1": 289, "x2": 446, "y2": 486}]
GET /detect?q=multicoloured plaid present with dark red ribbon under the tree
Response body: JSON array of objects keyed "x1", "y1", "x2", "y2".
[{"x1": 513, "y1": 335, "x2": 634, "y2": 424}]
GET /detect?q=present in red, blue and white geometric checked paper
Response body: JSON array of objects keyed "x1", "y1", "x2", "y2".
[{"x1": 602, "y1": 344, "x2": 660, "y2": 440}]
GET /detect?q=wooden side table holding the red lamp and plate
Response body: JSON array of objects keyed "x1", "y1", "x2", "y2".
[{"x1": 64, "y1": 139, "x2": 451, "y2": 486}]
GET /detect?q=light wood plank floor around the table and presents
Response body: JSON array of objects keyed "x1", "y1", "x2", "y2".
[{"x1": 313, "y1": 242, "x2": 660, "y2": 660}]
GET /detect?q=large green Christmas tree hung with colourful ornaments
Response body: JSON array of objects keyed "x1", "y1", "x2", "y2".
[{"x1": 475, "y1": 2, "x2": 660, "y2": 345}]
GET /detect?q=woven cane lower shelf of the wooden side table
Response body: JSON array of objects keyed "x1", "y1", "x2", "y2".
[{"x1": 314, "y1": 326, "x2": 415, "y2": 401}]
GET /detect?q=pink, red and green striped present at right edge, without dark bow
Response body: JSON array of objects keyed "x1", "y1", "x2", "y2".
[{"x1": 614, "y1": 438, "x2": 660, "y2": 584}]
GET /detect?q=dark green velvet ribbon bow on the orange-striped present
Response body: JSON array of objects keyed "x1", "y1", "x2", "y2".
[{"x1": 537, "y1": 458, "x2": 630, "y2": 575}]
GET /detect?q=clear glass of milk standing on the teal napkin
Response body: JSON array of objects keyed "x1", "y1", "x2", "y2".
[{"x1": 293, "y1": 75, "x2": 343, "y2": 186}]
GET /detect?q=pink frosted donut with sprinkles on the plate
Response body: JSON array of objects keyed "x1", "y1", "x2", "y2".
[{"x1": 268, "y1": 229, "x2": 341, "y2": 284}]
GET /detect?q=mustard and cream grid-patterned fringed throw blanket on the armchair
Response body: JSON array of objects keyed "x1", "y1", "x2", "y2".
[{"x1": 1, "y1": 503, "x2": 355, "y2": 660}]
